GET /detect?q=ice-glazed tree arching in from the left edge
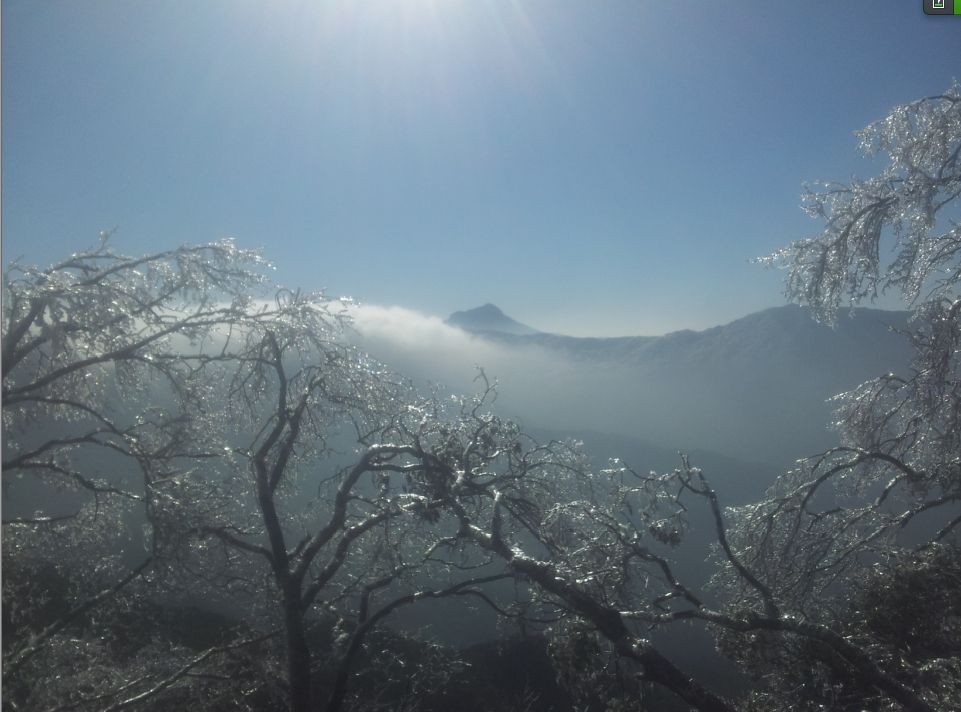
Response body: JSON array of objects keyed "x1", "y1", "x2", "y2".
[{"x1": 2, "y1": 234, "x2": 300, "y2": 708}]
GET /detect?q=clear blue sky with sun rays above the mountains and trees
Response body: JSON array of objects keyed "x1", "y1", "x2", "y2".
[{"x1": 2, "y1": 0, "x2": 961, "y2": 335}]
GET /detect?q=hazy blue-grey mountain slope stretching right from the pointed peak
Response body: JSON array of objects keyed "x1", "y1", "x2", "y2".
[{"x1": 438, "y1": 305, "x2": 911, "y2": 465}]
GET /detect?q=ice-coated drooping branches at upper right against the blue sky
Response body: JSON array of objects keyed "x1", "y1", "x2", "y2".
[{"x1": 763, "y1": 84, "x2": 961, "y2": 321}]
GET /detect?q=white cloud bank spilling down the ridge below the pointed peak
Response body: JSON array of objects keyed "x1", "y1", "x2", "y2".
[{"x1": 349, "y1": 304, "x2": 700, "y2": 454}]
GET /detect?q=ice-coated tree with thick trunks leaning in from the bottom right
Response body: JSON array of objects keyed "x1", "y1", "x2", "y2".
[{"x1": 410, "y1": 390, "x2": 936, "y2": 711}]
